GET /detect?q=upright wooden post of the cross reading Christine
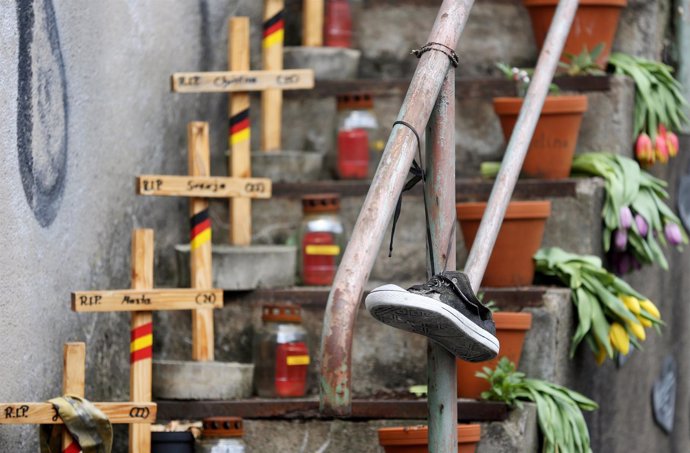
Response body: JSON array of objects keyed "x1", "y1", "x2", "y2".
[{"x1": 228, "y1": 17, "x2": 252, "y2": 245}]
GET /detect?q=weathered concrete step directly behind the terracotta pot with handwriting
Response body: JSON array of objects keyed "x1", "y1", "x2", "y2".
[{"x1": 242, "y1": 76, "x2": 635, "y2": 178}]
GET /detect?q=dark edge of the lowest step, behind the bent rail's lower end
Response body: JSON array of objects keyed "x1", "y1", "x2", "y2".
[{"x1": 156, "y1": 397, "x2": 509, "y2": 422}]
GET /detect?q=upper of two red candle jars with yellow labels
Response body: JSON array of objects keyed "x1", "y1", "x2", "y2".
[{"x1": 299, "y1": 194, "x2": 345, "y2": 286}]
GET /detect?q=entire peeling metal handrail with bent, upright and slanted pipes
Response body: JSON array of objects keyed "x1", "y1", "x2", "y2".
[{"x1": 320, "y1": 0, "x2": 578, "y2": 453}]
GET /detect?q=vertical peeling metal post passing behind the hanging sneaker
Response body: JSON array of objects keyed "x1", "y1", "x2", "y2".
[{"x1": 425, "y1": 70, "x2": 458, "y2": 453}]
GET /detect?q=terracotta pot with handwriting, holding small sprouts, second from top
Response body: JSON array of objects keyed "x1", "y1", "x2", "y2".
[{"x1": 494, "y1": 95, "x2": 587, "y2": 179}]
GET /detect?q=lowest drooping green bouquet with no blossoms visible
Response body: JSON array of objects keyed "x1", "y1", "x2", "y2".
[{"x1": 477, "y1": 357, "x2": 599, "y2": 453}]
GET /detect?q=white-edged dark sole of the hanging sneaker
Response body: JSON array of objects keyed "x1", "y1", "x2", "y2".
[{"x1": 364, "y1": 285, "x2": 500, "y2": 362}]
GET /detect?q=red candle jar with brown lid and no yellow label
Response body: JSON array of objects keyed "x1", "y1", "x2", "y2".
[{"x1": 336, "y1": 93, "x2": 383, "y2": 179}]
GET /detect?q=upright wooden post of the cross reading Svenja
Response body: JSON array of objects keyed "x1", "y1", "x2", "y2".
[{"x1": 187, "y1": 122, "x2": 213, "y2": 362}]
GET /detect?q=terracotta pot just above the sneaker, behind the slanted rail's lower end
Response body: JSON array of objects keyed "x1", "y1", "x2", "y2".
[{"x1": 456, "y1": 201, "x2": 551, "y2": 287}]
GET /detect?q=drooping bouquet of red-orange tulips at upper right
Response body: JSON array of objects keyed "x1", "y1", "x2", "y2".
[{"x1": 609, "y1": 53, "x2": 688, "y2": 166}]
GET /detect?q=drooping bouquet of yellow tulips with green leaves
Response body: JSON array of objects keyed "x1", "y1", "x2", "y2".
[{"x1": 534, "y1": 247, "x2": 662, "y2": 364}]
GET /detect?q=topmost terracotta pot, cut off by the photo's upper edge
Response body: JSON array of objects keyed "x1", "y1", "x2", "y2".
[{"x1": 522, "y1": 0, "x2": 628, "y2": 68}]
